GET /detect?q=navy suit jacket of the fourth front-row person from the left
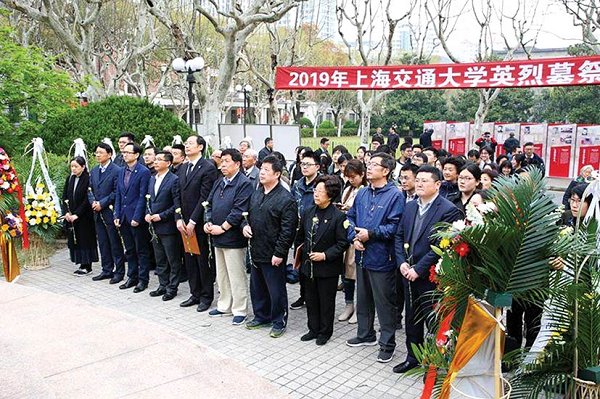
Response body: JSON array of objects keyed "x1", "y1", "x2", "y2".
[{"x1": 146, "y1": 172, "x2": 181, "y2": 234}]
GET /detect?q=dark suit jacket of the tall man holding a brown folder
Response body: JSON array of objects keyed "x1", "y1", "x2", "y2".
[{"x1": 175, "y1": 158, "x2": 218, "y2": 234}]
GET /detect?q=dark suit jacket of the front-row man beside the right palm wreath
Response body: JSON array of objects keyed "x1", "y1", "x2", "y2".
[{"x1": 395, "y1": 195, "x2": 462, "y2": 285}]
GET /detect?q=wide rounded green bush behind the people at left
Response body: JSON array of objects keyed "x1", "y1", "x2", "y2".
[{"x1": 40, "y1": 96, "x2": 192, "y2": 154}]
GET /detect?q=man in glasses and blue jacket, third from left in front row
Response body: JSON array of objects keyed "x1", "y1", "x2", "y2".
[{"x1": 115, "y1": 143, "x2": 150, "y2": 293}]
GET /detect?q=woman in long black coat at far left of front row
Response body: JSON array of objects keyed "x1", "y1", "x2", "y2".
[{"x1": 62, "y1": 157, "x2": 98, "y2": 276}]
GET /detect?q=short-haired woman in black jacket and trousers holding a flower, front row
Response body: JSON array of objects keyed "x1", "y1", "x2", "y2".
[{"x1": 296, "y1": 176, "x2": 348, "y2": 345}]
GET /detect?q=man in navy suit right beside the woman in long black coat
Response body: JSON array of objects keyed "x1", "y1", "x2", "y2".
[{"x1": 88, "y1": 143, "x2": 125, "y2": 284}]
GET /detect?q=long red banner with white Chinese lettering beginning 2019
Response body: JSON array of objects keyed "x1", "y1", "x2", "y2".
[{"x1": 275, "y1": 56, "x2": 600, "y2": 90}]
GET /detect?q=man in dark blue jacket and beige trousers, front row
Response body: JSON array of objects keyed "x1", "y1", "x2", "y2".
[{"x1": 204, "y1": 148, "x2": 254, "y2": 325}]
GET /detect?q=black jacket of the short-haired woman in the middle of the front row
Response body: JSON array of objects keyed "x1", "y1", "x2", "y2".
[{"x1": 296, "y1": 204, "x2": 348, "y2": 277}]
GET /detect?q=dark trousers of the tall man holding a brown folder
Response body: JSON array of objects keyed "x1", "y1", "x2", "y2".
[{"x1": 185, "y1": 234, "x2": 215, "y2": 305}]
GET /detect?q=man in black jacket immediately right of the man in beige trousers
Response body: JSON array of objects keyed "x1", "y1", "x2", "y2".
[{"x1": 242, "y1": 156, "x2": 298, "y2": 338}]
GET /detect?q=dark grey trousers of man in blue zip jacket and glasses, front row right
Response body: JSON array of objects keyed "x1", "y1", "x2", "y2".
[{"x1": 356, "y1": 266, "x2": 397, "y2": 350}]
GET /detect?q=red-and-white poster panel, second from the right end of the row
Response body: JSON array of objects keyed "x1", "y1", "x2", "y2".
[{"x1": 546, "y1": 124, "x2": 577, "y2": 178}]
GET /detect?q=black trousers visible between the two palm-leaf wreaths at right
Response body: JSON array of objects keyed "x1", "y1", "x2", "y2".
[{"x1": 506, "y1": 301, "x2": 542, "y2": 352}]
